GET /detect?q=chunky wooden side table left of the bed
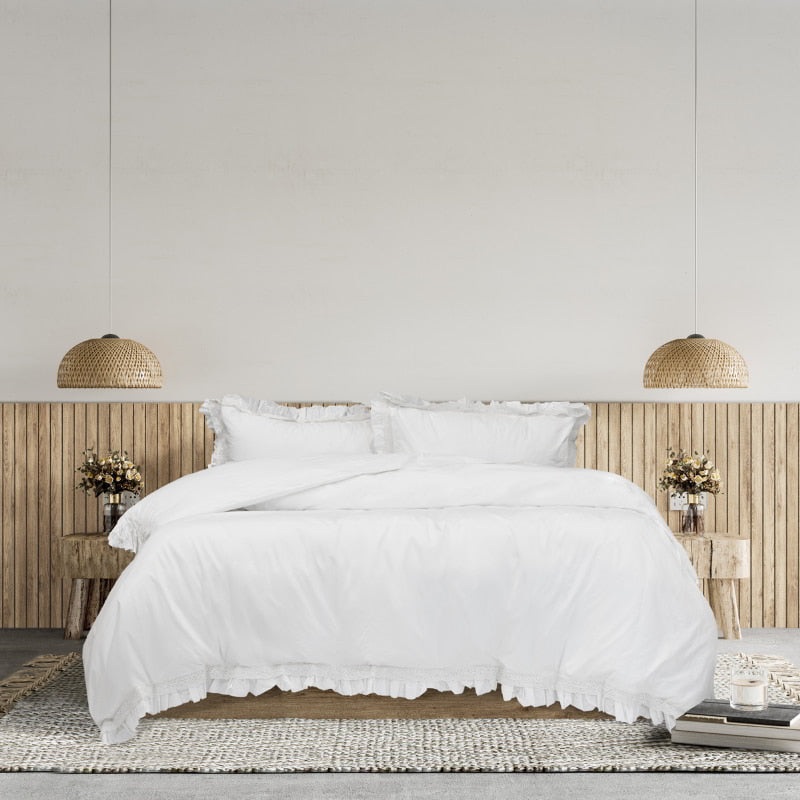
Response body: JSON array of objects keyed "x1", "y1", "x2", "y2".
[{"x1": 61, "y1": 533, "x2": 133, "y2": 639}]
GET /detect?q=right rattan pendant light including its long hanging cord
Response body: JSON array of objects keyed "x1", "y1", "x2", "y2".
[{"x1": 644, "y1": 0, "x2": 750, "y2": 389}]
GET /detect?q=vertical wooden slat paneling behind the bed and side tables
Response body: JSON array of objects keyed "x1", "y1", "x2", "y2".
[{"x1": 0, "y1": 403, "x2": 800, "y2": 627}]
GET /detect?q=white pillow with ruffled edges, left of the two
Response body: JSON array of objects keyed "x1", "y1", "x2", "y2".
[{"x1": 200, "y1": 395, "x2": 373, "y2": 466}]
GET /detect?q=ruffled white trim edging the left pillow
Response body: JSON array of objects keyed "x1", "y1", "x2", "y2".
[{"x1": 200, "y1": 394, "x2": 370, "y2": 467}]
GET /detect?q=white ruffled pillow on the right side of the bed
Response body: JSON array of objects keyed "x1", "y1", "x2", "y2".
[{"x1": 372, "y1": 392, "x2": 591, "y2": 467}]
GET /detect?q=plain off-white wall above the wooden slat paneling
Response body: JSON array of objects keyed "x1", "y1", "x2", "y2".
[{"x1": 0, "y1": 0, "x2": 800, "y2": 401}]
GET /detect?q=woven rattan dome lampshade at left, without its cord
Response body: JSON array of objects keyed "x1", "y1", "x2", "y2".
[{"x1": 57, "y1": 333, "x2": 164, "y2": 389}]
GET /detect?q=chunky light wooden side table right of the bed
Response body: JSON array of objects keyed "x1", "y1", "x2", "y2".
[{"x1": 675, "y1": 533, "x2": 750, "y2": 639}]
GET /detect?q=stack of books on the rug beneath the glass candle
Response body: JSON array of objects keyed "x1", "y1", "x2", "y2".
[{"x1": 672, "y1": 700, "x2": 800, "y2": 753}]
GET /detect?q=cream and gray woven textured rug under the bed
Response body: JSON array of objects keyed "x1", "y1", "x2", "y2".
[{"x1": 0, "y1": 654, "x2": 800, "y2": 773}]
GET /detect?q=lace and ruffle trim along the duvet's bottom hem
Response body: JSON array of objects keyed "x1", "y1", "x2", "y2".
[{"x1": 99, "y1": 664, "x2": 688, "y2": 744}]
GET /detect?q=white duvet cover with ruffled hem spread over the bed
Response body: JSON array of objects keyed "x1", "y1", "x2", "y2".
[{"x1": 84, "y1": 455, "x2": 716, "y2": 743}]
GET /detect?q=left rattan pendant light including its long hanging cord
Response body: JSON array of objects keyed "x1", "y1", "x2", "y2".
[{"x1": 57, "y1": 0, "x2": 164, "y2": 389}]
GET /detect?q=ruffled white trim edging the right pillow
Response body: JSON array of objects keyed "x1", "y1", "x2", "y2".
[{"x1": 372, "y1": 392, "x2": 592, "y2": 456}]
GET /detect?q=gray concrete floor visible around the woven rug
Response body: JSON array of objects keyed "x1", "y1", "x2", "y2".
[{"x1": 0, "y1": 628, "x2": 800, "y2": 800}]
